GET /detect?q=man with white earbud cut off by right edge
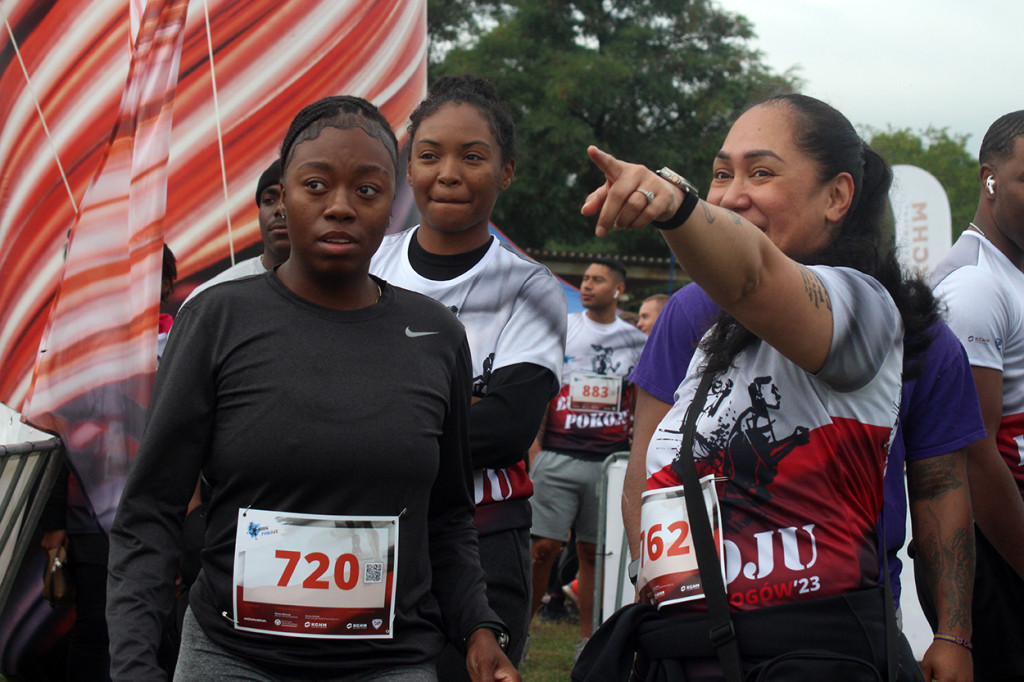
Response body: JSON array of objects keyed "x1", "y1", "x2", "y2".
[{"x1": 932, "y1": 111, "x2": 1024, "y2": 681}]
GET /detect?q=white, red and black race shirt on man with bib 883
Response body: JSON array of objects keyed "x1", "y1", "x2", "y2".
[{"x1": 543, "y1": 312, "x2": 647, "y2": 460}]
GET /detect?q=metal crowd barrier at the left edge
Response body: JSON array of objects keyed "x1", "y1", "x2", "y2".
[{"x1": 0, "y1": 436, "x2": 63, "y2": 612}]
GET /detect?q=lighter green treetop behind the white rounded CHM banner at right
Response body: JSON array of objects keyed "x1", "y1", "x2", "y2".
[{"x1": 869, "y1": 127, "x2": 980, "y2": 241}]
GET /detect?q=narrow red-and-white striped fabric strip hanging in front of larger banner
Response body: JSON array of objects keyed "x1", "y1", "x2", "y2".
[{"x1": 24, "y1": 0, "x2": 188, "y2": 526}]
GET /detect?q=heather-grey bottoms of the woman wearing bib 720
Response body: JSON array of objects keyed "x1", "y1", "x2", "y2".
[{"x1": 174, "y1": 608, "x2": 437, "y2": 682}]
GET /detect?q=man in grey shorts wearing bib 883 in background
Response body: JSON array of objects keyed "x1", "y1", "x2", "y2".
[{"x1": 530, "y1": 258, "x2": 647, "y2": 652}]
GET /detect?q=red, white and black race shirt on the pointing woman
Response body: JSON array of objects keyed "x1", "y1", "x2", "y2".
[{"x1": 647, "y1": 266, "x2": 903, "y2": 609}]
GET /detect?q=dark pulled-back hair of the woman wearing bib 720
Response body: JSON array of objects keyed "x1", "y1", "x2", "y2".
[{"x1": 281, "y1": 95, "x2": 398, "y2": 183}]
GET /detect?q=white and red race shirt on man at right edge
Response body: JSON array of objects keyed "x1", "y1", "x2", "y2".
[{"x1": 932, "y1": 230, "x2": 1024, "y2": 495}]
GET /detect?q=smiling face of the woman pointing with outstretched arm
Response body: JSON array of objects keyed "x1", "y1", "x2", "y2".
[{"x1": 708, "y1": 104, "x2": 853, "y2": 256}]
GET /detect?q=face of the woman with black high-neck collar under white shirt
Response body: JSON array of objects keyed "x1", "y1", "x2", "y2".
[{"x1": 408, "y1": 103, "x2": 515, "y2": 235}]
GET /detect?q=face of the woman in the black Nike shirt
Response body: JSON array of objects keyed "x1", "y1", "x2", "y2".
[{"x1": 283, "y1": 127, "x2": 395, "y2": 279}]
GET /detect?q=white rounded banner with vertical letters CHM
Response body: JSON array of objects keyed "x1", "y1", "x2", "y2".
[{"x1": 889, "y1": 164, "x2": 952, "y2": 276}]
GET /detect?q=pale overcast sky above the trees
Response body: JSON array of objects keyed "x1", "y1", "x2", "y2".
[{"x1": 718, "y1": 0, "x2": 1024, "y2": 156}]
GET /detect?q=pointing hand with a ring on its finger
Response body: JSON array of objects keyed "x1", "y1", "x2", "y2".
[{"x1": 581, "y1": 144, "x2": 685, "y2": 237}]
